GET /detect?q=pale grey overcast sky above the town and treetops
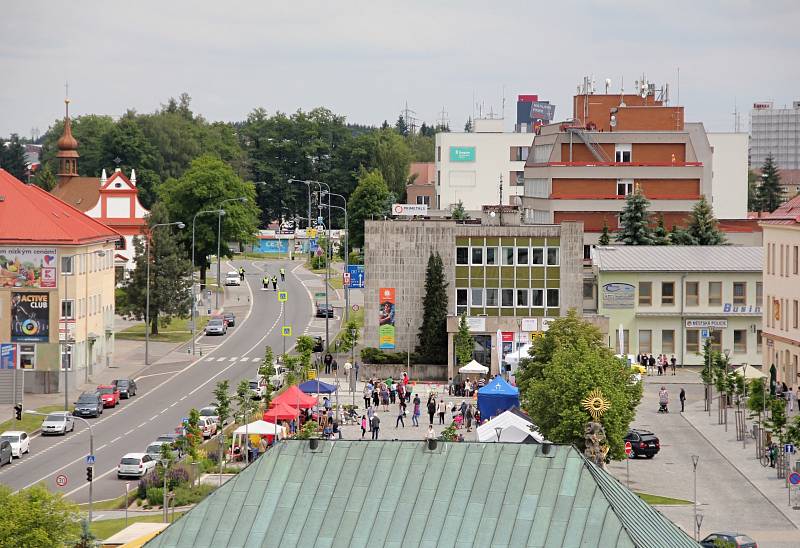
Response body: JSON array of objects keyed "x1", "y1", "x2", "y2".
[{"x1": 0, "y1": 0, "x2": 800, "y2": 136}]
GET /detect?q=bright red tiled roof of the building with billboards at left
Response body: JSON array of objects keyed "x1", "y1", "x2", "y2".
[{"x1": 0, "y1": 169, "x2": 121, "y2": 245}]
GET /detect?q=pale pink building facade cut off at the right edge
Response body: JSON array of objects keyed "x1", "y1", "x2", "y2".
[{"x1": 760, "y1": 196, "x2": 800, "y2": 388}]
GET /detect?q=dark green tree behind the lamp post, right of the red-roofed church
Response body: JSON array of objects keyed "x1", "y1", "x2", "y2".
[{"x1": 120, "y1": 202, "x2": 191, "y2": 335}]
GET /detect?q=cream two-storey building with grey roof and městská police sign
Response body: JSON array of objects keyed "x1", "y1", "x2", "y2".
[{"x1": 592, "y1": 246, "x2": 763, "y2": 365}]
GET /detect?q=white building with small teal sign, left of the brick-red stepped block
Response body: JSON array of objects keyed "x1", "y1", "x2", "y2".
[{"x1": 436, "y1": 119, "x2": 534, "y2": 211}]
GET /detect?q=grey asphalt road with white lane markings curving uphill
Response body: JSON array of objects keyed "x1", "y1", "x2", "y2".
[{"x1": 0, "y1": 261, "x2": 318, "y2": 502}]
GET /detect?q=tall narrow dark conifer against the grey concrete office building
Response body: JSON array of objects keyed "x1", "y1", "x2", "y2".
[{"x1": 416, "y1": 252, "x2": 448, "y2": 364}]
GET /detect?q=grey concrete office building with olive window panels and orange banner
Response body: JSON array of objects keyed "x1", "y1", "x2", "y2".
[{"x1": 364, "y1": 214, "x2": 583, "y2": 376}]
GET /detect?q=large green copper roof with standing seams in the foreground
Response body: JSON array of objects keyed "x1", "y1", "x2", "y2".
[{"x1": 146, "y1": 440, "x2": 697, "y2": 548}]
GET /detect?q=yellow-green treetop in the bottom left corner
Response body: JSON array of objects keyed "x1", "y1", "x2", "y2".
[{"x1": 0, "y1": 484, "x2": 81, "y2": 548}]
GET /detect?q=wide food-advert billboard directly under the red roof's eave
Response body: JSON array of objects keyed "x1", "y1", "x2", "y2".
[{"x1": 0, "y1": 247, "x2": 58, "y2": 289}]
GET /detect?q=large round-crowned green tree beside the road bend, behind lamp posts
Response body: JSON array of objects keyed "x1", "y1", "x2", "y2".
[{"x1": 158, "y1": 155, "x2": 259, "y2": 284}]
